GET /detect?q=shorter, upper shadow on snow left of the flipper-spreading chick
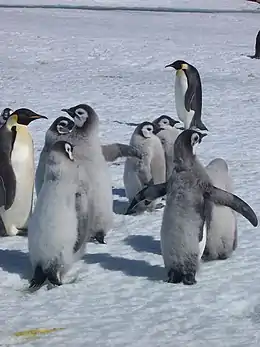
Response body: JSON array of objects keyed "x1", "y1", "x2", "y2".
[{"x1": 124, "y1": 235, "x2": 161, "y2": 255}]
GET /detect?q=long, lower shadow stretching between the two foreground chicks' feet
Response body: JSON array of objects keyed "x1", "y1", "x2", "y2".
[{"x1": 84, "y1": 253, "x2": 165, "y2": 281}]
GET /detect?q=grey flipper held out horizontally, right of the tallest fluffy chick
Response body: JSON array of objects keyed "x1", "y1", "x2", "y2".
[{"x1": 102, "y1": 143, "x2": 142, "y2": 162}]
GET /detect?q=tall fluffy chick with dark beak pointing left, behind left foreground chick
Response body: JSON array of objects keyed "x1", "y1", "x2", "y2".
[{"x1": 62, "y1": 104, "x2": 113, "y2": 243}]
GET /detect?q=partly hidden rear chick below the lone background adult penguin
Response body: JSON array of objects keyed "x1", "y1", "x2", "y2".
[{"x1": 153, "y1": 115, "x2": 182, "y2": 180}]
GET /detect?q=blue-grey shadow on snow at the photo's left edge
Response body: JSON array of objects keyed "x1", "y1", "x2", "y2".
[{"x1": 0, "y1": 249, "x2": 31, "y2": 279}]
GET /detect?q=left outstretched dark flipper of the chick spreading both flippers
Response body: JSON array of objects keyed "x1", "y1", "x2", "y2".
[{"x1": 125, "y1": 183, "x2": 167, "y2": 215}]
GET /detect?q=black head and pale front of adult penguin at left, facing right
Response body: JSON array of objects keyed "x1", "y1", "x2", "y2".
[{"x1": 1, "y1": 108, "x2": 47, "y2": 236}]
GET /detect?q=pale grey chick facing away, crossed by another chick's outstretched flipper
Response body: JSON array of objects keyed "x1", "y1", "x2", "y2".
[{"x1": 203, "y1": 158, "x2": 237, "y2": 260}]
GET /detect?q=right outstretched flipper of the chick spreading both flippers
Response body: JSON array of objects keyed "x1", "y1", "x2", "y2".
[{"x1": 204, "y1": 186, "x2": 258, "y2": 227}]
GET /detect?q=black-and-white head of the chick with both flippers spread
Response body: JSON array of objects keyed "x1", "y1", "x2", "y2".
[{"x1": 174, "y1": 129, "x2": 207, "y2": 157}]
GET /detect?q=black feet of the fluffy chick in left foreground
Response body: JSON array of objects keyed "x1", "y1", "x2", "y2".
[{"x1": 29, "y1": 265, "x2": 62, "y2": 291}]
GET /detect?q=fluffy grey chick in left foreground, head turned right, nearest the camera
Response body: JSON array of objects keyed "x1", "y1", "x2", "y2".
[{"x1": 28, "y1": 140, "x2": 82, "y2": 290}]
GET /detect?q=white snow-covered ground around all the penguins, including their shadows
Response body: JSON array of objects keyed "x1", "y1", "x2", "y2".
[{"x1": 0, "y1": 0, "x2": 260, "y2": 347}]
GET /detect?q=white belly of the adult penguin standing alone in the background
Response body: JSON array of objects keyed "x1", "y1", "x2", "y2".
[{"x1": 175, "y1": 71, "x2": 194, "y2": 129}]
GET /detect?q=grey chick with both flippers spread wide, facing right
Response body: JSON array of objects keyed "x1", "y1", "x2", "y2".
[{"x1": 128, "y1": 129, "x2": 258, "y2": 285}]
